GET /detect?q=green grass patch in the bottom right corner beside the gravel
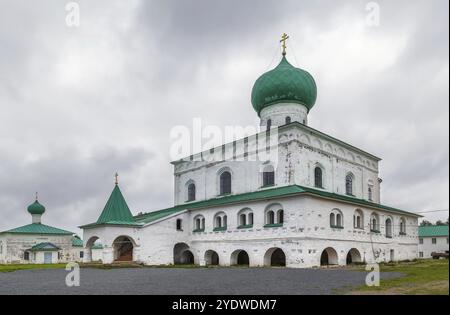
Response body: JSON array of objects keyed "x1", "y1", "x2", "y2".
[{"x1": 350, "y1": 259, "x2": 449, "y2": 295}]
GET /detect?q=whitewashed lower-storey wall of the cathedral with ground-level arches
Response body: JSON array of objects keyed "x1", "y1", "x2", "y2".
[{"x1": 84, "y1": 196, "x2": 418, "y2": 268}]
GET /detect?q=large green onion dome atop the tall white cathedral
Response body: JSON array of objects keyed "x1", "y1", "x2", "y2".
[{"x1": 252, "y1": 56, "x2": 317, "y2": 115}]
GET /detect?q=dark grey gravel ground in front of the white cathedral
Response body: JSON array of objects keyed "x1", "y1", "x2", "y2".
[{"x1": 0, "y1": 268, "x2": 401, "y2": 295}]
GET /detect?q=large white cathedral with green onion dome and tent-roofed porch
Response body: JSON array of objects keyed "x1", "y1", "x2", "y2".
[{"x1": 81, "y1": 38, "x2": 420, "y2": 268}]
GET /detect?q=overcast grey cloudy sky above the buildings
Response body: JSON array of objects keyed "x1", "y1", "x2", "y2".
[{"x1": 0, "y1": 0, "x2": 449, "y2": 232}]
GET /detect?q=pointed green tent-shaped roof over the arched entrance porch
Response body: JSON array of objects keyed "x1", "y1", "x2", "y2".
[{"x1": 97, "y1": 184, "x2": 134, "y2": 225}]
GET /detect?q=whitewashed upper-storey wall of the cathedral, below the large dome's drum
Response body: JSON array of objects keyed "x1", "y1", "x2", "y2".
[{"x1": 174, "y1": 125, "x2": 380, "y2": 204}]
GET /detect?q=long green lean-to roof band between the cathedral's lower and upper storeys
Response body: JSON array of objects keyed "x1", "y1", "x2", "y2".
[{"x1": 134, "y1": 185, "x2": 420, "y2": 224}]
